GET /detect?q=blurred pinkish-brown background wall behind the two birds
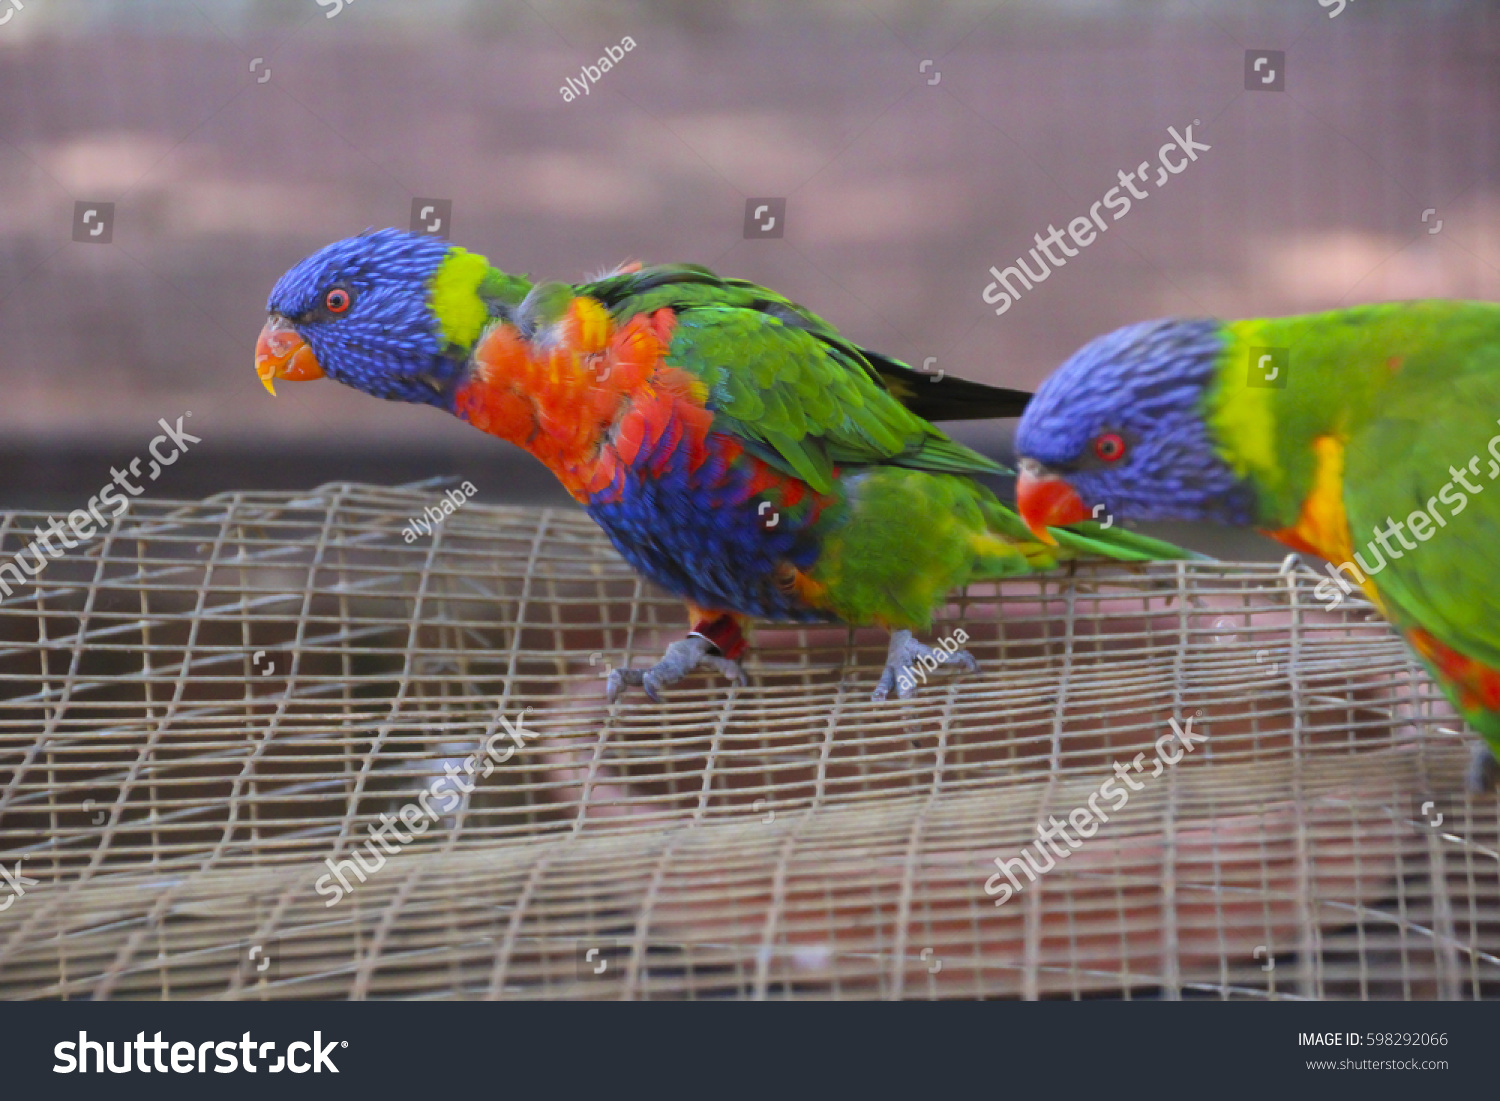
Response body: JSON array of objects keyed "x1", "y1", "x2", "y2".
[{"x1": 0, "y1": 0, "x2": 1500, "y2": 522}]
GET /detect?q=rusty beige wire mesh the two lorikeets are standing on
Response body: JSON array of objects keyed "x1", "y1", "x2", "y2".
[{"x1": 0, "y1": 485, "x2": 1500, "y2": 998}]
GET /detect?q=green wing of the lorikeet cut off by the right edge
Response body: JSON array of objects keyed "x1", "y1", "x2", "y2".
[{"x1": 1344, "y1": 315, "x2": 1500, "y2": 669}]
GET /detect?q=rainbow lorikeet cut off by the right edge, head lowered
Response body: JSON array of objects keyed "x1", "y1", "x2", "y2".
[{"x1": 1016, "y1": 300, "x2": 1500, "y2": 788}]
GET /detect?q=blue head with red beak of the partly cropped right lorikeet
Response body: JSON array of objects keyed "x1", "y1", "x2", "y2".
[{"x1": 1016, "y1": 321, "x2": 1256, "y2": 531}]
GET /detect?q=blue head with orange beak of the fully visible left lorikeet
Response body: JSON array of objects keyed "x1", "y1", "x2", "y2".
[{"x1": 255, "y1": 230, "x2": 470, "y2": 405}]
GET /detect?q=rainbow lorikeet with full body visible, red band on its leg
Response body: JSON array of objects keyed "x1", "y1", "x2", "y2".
[{"x1": 257, "y1": 230, "x2": 1184, "y2": 699}]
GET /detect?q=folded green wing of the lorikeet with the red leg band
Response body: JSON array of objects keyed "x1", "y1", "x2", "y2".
[{"x1": 578, "y1": 264, "x2": 1028, "y2": 494}]
